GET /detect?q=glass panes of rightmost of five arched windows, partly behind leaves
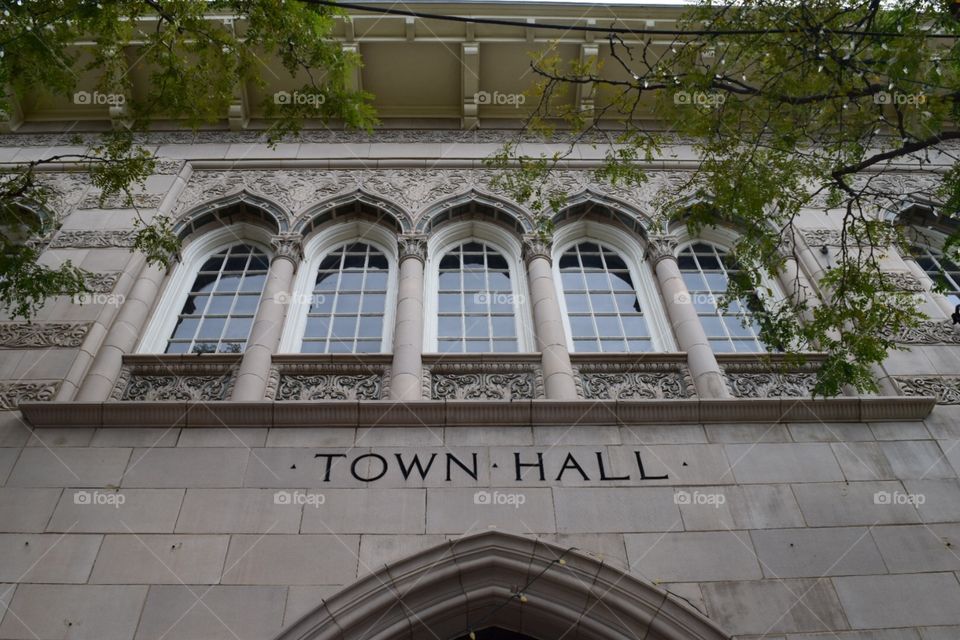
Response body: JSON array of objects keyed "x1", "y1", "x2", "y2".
[{"x1": 677, "y1": 240, "x2": 766, "y2": 352}]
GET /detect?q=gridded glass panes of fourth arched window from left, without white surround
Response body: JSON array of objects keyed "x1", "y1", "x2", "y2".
[{"x1": 560, "y1": 242, "x2": 653, "y2": 352}]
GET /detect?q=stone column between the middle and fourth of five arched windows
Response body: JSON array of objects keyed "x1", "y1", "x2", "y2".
[{"x1": 523, "y1": 236, "x2": 577, "y2": 400}]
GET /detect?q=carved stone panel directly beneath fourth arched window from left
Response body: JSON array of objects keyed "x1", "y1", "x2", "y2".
[{"x1": 574, "y1": 362, "x2": 697, "y2": 400}]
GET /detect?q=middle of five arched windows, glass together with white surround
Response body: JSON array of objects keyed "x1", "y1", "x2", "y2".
[{"x1": 424, "y1": 222, "x2": 533, "y2": 353}]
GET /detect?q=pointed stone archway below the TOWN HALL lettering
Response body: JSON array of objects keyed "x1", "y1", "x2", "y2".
[{"x1": 276, "y1": 531, "x2": 729, "y2": 640}]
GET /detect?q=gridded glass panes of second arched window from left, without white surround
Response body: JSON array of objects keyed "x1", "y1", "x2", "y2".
[{"x1": 300, "y1": 242, "x2": 389, "y2": 353}]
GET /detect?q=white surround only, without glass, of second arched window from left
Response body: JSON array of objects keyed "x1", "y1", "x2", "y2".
[{"x1": 277, "y1": 220, "x2": 399, "y2": 355}]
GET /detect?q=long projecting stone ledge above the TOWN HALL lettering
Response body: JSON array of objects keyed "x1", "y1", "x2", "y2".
[{"x1": 20, "y1": 396, "x2": 936, "y2": 428}]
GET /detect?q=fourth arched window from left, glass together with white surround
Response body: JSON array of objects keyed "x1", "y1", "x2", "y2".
[{"x1": 554, "y1": 221, "x2": 675, "y2": 353}]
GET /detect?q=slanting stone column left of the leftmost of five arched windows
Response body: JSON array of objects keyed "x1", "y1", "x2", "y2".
[{"x1": 75, "y1": 263, "x2": 172, "y2": 402}]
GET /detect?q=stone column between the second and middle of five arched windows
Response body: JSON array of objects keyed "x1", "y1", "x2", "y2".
[{"x1": 390, "y1": 235, "x2": 427, "y2": 402}]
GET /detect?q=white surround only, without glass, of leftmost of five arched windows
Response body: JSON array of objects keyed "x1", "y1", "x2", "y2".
[{"x1": 136, "y1": 222, "x2": 273, "y2": 354}]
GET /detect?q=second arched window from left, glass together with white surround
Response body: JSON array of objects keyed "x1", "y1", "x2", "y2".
[{"x1": 280, "y1": 221, "x2": 396, "y2": 354}]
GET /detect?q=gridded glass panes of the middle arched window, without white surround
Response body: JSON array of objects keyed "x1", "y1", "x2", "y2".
[{"x1": 437, "y1": 242, "x2": 519, "y2": 353}]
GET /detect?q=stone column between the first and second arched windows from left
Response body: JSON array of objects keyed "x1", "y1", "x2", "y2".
[{"x1": 231, "y1": 233, "x2": 302, "y2": 402}]
